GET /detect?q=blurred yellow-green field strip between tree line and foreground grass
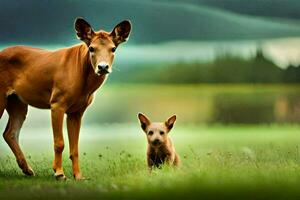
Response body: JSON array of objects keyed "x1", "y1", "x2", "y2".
[{"x1": 7, "y1": 84, "x2": 300, "y2": 126}]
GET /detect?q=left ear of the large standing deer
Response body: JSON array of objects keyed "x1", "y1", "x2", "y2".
[{"x1": 75, "y1": 17, "x2": 95, "y2": 46}]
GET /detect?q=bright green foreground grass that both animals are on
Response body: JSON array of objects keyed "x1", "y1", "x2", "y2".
[{"x1": 0, "y1": 124, "x2": 300, "y2": 199}]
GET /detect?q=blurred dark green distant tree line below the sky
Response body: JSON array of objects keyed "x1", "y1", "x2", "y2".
[{"x1": 113, "y1": 51, "x2": 300, "y2": 83}]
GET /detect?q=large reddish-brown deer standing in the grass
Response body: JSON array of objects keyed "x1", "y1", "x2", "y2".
[{"x1": 0, "y1": 18, "x2": 131, "y2": 180}]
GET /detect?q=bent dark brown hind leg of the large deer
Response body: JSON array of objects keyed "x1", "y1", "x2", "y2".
[{"x1": 3, "y1": 95, "x2": 34, "y2": 176}]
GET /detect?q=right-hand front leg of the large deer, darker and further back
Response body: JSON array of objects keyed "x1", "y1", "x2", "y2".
[{"x1": 67, "y1": 113, "x2": 83, "y2": 180}]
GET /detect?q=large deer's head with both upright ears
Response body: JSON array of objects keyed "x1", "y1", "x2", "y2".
[{"x1": 75, "y1": 18, "x2": 131, "y2": 75}]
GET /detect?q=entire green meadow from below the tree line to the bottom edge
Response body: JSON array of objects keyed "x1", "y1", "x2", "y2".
[{"x1": 0, "y1": 83, "x2": 300, "y2": 199}]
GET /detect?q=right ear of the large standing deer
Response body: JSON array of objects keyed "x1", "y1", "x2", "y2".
[{"x1": 110, "y1": 20, "x2": 131, "y2": 46}]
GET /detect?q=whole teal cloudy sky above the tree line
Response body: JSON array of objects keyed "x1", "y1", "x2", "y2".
[{"x1": 0, "y1": 0, "x2": 300, "y2": 67}]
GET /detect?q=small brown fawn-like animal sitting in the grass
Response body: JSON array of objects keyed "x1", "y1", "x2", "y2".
[{"x1": 138, "y1": 113, "x2": 180, "y2": 169}]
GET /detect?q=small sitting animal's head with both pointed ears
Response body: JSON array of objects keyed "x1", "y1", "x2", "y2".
[{"x1": 138, "y1": 113, "x2": 176, "y2": 148}]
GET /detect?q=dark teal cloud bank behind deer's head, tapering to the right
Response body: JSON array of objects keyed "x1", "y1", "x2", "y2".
[{"x1": 0, "y1": 0, "x2": 300, "y2": 45}]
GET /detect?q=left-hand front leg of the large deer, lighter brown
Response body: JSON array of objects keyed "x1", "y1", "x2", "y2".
[{"x1": 51, "y1": 104, "x2": 66, "y2": 180}]
